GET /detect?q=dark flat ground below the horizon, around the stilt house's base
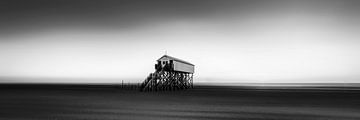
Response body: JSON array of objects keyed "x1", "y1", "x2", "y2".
[{"x1": 0, "y1": 85, "x2": 360, "y2": 120}]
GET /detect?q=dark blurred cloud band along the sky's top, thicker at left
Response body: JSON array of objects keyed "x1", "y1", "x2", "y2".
[{"x1": 0, "y1": 0, "x2": 359, "y2": 36}]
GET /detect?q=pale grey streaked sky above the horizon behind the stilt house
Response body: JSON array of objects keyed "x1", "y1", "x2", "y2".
[{"x1": 0, "y1": 0, "x2": 360, "y2": 83}]
